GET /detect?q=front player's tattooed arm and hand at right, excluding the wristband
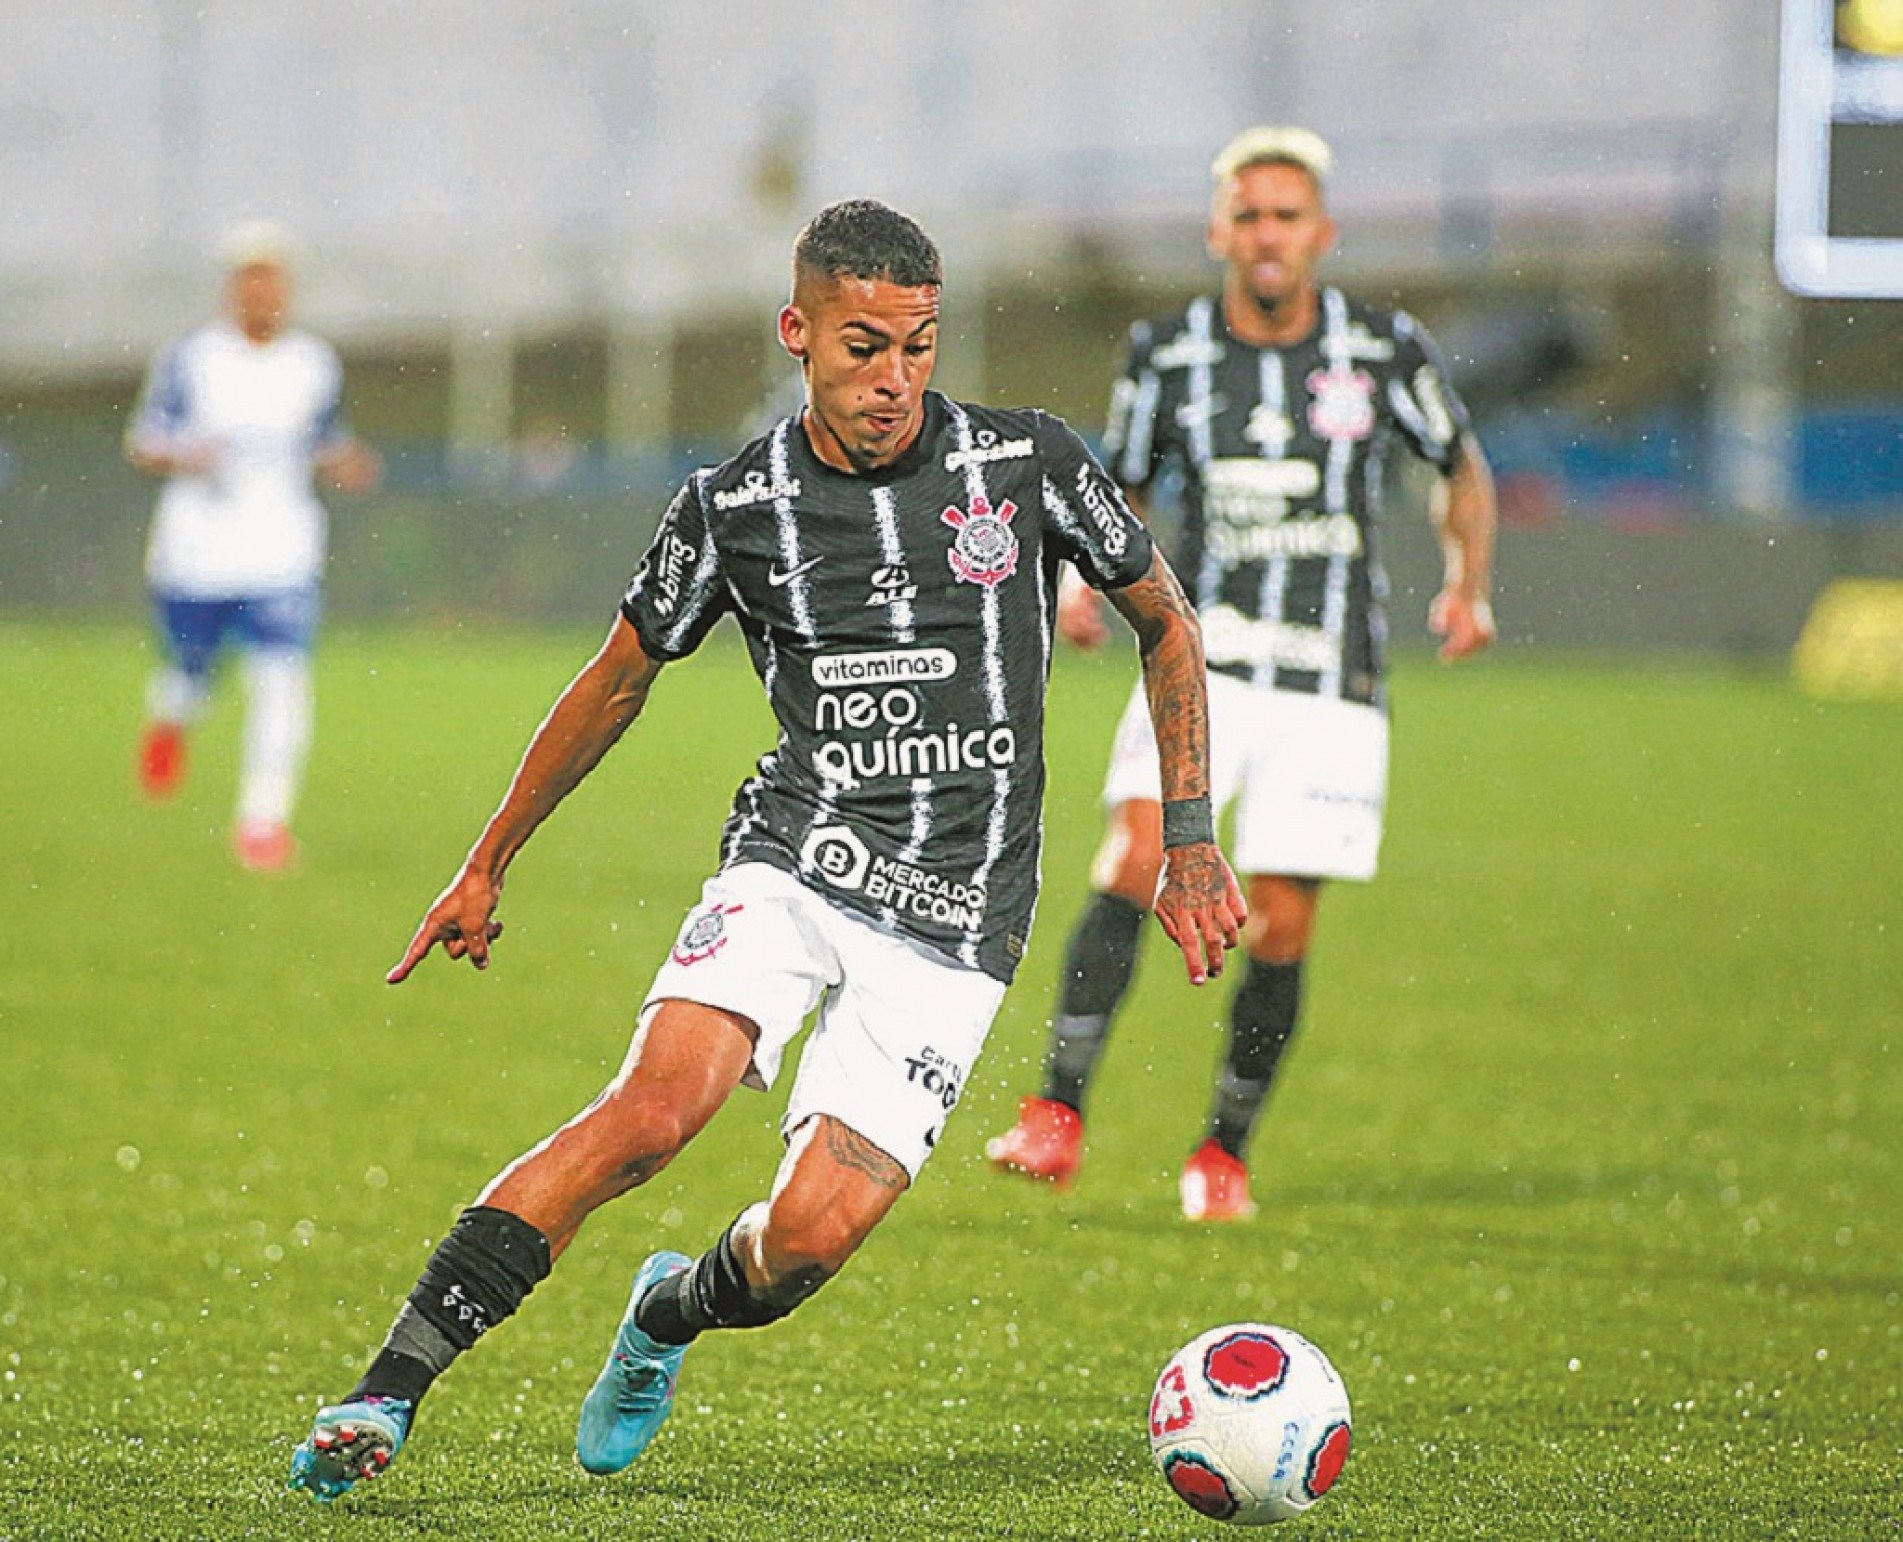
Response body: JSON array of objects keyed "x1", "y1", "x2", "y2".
[{"x1": 1109, "y1": 552, "x2": 1248, "y2": 984}]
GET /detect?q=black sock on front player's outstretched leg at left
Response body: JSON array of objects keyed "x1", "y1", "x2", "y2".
[{"x1": 350, "y1": 1205, "x2": 548, "y2": 1403}]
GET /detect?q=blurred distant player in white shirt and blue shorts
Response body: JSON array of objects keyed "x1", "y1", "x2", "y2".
[{"x1": 126, "y1": 223, "x2": 381, "y2": 872}]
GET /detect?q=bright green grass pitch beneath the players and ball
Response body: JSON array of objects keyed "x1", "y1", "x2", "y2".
[{"x1": 0, "y1": 621, "x2": 1903, "y2": 1542}]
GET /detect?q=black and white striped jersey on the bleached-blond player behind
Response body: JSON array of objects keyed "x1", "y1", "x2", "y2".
[{"x1": 1104, "y1": 289, "x2": 1469, "y2": 702}]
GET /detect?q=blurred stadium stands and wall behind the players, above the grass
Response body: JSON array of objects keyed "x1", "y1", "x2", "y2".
[{"x1": 11, "y1": 0, "x2": 1903, "y2": 655}]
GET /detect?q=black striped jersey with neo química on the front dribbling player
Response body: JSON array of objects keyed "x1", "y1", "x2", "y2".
[{"x1": 622, "y1": 392, "x2": 1153, "y2": 980}]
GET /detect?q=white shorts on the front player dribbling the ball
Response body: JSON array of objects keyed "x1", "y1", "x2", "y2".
[{"x1": 641, "y1": 862, "x2": 1005, "y2": 1178}]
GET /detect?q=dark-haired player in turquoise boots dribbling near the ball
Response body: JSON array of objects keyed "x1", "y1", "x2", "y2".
[{"x1": 291, "y1": 202, "x2": 1245, "y2": 1498}]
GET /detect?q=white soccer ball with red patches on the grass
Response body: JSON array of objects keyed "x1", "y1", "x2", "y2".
[{"x1": 1149, "y1": 1323, "x2": 1349, "y2": 1527}]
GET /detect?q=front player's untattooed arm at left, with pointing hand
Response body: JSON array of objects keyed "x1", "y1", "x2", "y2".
[{"x1": 386, "y1": 617, "x2": 660, "y2": 984}]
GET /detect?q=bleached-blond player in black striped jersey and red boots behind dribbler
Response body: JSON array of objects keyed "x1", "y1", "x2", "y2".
[{"x1": 986, "y1": 128, "x2": 1494, "y2": 1220}]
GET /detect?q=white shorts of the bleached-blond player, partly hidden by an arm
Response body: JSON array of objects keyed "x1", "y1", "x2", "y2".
[{"x1": 1104, "y1": 674, "x2": 1387, "y2": 880}]
